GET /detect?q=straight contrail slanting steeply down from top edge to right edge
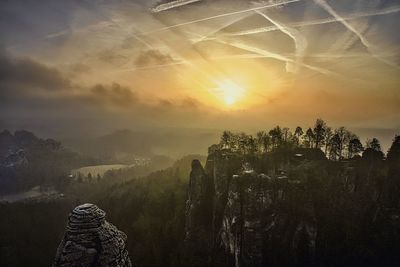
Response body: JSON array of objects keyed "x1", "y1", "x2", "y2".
[{"x1": 314, "y1": 0, "x2": 400, "y2": 69}]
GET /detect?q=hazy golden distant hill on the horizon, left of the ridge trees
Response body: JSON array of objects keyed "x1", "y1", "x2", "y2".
[{"x1": 63, "y1": 129, "x2": 220, "y2": 160}]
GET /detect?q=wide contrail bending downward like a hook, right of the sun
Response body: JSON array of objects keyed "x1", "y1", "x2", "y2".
[{"x1": 256, "y1": 10, "x2": 308, "y2": 72}]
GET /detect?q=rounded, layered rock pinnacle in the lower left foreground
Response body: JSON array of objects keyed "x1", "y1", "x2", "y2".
[{"x1": 54, "y1": 204, "x2": 132, "y2": 267}]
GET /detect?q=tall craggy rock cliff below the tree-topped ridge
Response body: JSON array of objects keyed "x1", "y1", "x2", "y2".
[{"x1": 186, "y1": 154, "x2": 317, "y2": 267}]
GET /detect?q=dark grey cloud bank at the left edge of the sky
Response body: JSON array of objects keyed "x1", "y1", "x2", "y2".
[{"x1": 0, "y1": 51, "x2": 137, "y2": 109}]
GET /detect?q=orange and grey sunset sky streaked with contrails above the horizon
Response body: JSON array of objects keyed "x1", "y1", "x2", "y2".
[{"x1": 0, "y1": 0, "x2": 400, "y2": 146}]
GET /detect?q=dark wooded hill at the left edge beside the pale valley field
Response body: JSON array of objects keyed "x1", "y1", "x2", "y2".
[{"x1": 0, "y1": 130, "x2": 99, "y2": 193}]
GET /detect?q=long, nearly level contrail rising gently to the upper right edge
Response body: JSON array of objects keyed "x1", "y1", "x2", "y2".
[{"x1": 221, "y1": 6, "x2": 400, "y2": 36}]
